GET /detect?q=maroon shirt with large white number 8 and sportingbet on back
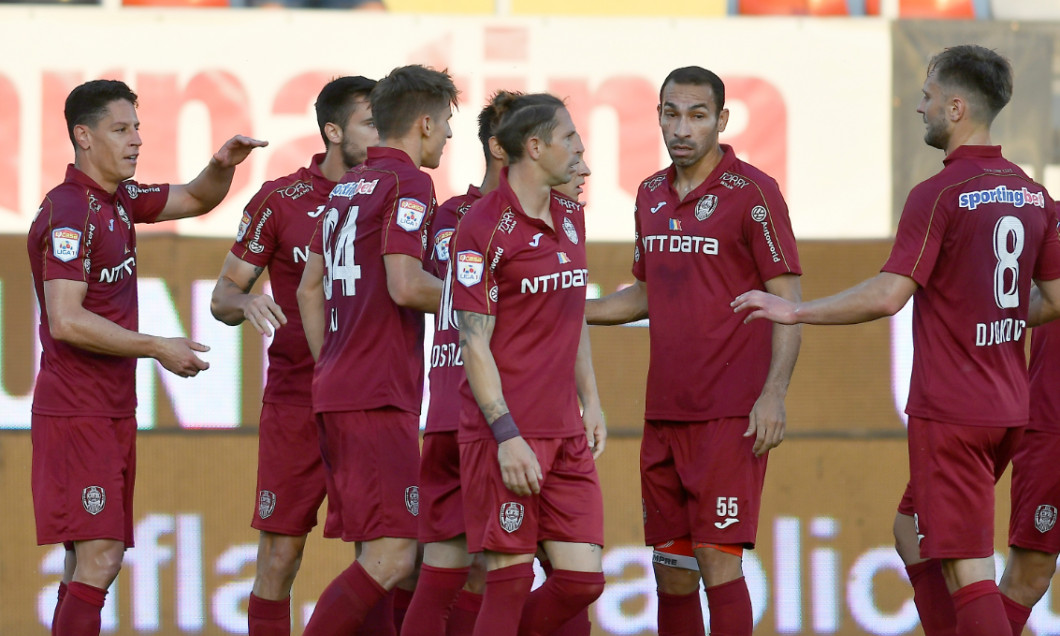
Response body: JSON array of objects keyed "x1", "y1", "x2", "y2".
[{"x1": 883, "y1": 145, "x2": 1060, "y2": 426}]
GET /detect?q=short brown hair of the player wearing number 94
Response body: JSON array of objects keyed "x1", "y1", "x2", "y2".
[{"x1": 371, "y1": 64, "x2": 460, "y2": 139}]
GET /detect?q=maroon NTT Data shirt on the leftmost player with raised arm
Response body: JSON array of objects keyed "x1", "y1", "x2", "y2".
[{"x1": 27, "y1": 165, "x2": 170, "y2": 418}]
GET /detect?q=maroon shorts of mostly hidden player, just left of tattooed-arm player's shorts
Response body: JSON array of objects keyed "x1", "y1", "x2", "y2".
[{"x1": 420, "y1": 430, "x2": 464, "y2": 543}]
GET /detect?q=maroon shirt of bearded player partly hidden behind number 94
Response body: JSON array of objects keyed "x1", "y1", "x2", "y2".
[{"x1": 231, "y1": 154, "x2": 335, "y2": 406}]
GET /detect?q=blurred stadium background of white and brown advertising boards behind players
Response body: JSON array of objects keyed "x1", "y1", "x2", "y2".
[{"x1": 0, "y1": 0, "x2": 1060, "y2": 635}]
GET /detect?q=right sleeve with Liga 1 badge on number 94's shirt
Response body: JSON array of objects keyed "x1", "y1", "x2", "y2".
[{"x1": 382, "y1": 173, "x2": 435, "y2": 261}]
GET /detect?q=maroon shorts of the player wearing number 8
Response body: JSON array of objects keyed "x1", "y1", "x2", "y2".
[{"x1": 909, "y1": 417, "x2": 1023, "y2": 559}]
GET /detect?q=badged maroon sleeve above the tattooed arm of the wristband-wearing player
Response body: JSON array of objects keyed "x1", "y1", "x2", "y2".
[{"x1": 451, "y1": 208, "x2": 505, "y2": 316}]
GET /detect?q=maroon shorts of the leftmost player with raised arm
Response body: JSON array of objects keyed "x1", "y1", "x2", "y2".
[{"x1": 31, "y1": 413, "x2": 136, "y2": 548}]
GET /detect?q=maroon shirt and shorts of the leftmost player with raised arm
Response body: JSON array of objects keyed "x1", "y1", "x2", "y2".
[{"x1": 27, "y1": 165, "x2": 170, "y2": 547}]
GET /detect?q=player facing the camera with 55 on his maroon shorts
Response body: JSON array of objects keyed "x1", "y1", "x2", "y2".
[{"x1": 586, "y1": 67, "x2": 801, "y2": 635}]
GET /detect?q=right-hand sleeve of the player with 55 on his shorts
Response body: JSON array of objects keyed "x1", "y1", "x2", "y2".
[{"x1": 744, "y1": 181, "x2": 802, "y2": 281}]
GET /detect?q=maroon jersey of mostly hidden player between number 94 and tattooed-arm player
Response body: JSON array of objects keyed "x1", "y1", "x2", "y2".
[{"x1": 425, "y1": 186, "x2": 482, "y2": 432}]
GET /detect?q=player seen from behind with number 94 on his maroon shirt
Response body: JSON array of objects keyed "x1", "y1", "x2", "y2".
[{"x1": 298, "y1": 65, "x2": 458, "y2": 636}]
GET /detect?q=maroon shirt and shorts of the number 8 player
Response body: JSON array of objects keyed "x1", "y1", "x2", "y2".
[{"x1": 883, "y1": 146, "x2": 1060, "y2": 559}]
